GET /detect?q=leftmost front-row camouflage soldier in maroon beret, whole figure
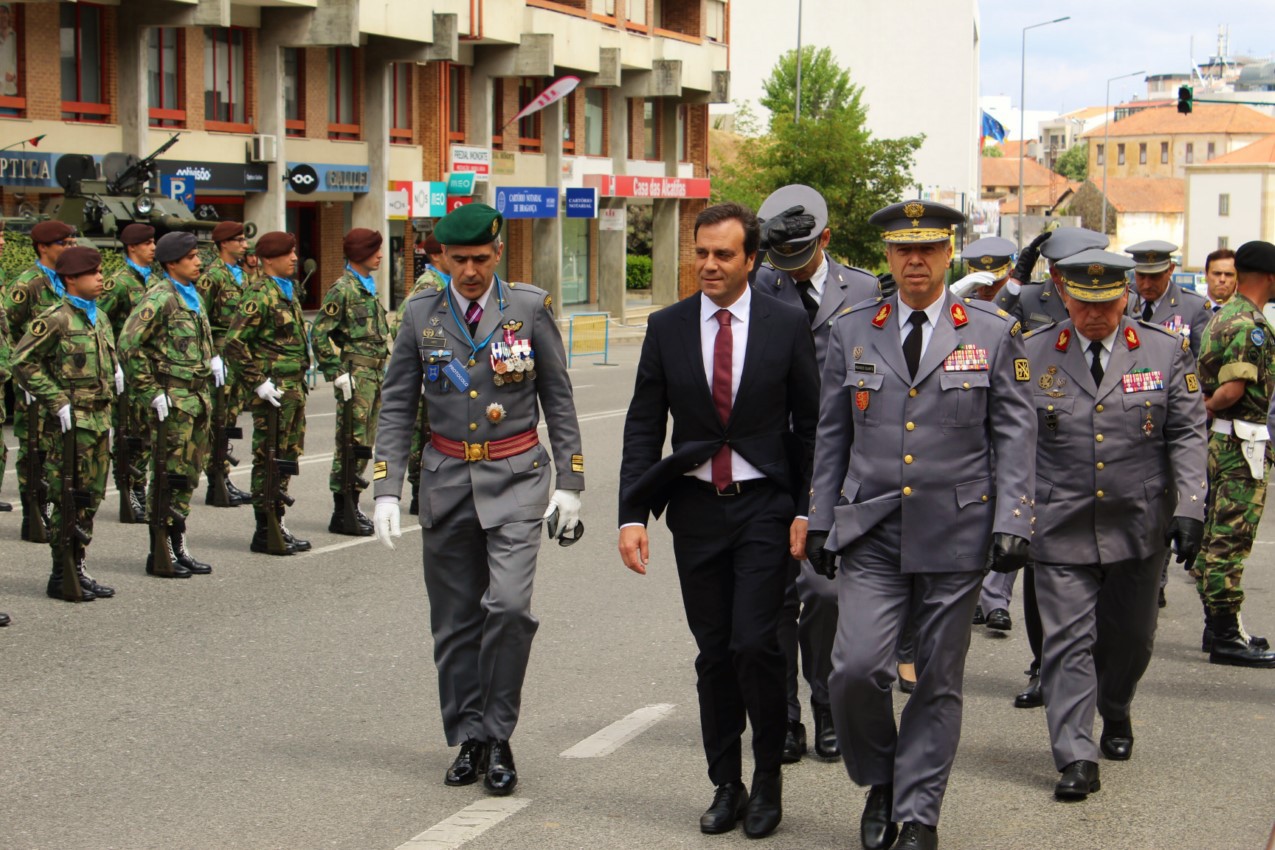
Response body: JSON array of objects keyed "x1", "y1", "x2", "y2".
[{"x1": 13, "y1": 247, "x2": 124, "y2": 601}]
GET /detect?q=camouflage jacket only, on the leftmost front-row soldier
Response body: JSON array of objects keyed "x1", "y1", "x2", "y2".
[{"x1": 13, "y1": 301, "x2": 119, "y2": 433}]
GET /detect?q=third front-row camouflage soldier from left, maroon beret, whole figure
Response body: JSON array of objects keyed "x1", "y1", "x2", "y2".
[{"x1": 226, "y1": 231, "x2": 310, "y2": 554}]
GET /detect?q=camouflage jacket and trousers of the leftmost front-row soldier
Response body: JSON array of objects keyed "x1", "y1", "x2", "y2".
[{"x1": 13, "y1": 301, "x2": 119, "y2": 593}]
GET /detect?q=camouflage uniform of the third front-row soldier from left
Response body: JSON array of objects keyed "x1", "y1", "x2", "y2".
[{"x1": 224, "y1": 278, "x2": 310, "y2": 511}]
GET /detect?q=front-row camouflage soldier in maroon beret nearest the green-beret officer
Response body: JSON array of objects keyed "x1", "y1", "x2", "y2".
[{"x1": 311, "y1": 227, "x2": 390, "y2": 537}]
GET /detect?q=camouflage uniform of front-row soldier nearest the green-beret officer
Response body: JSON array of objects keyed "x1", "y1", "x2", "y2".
[{"x1": 311, "y1": 269, "x2": 390, "y2": 493}]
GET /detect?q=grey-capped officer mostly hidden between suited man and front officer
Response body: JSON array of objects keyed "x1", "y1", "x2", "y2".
[{"x1": 754, "y1": 185, "x2": 880, "y2": 763}]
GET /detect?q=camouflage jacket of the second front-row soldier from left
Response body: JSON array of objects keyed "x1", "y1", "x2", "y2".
[{"x1": 120, "y1": 278, "x2": 213, "y2": 415}]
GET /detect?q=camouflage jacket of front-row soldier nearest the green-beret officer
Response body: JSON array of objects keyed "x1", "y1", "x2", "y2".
[{"x1": 310, "y1": 271, "x2": 390, "y2": 381}]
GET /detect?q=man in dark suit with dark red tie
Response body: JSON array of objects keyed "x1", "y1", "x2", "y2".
[{"x1": 620, "y1": 204, "x2": 819, "y2": 837}]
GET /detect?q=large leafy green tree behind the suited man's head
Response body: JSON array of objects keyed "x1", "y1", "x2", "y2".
[{"x1": 713, "y1": 47, "x2": 924, "y2": 268}]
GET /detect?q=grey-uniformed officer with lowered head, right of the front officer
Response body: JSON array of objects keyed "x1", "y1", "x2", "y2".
[{"x1": 1026, "y1": 250, "x2": 1207, "y2": 800}]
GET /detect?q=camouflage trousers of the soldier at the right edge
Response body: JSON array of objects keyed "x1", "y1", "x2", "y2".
[{"x1": 1191, "y1": 433, "x2": 1271, "y2": 613}]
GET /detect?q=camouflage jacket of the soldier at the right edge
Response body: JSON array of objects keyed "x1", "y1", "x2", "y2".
[{"x1": 1200, "y1": 292, "x2": 1275, "y2": 423}]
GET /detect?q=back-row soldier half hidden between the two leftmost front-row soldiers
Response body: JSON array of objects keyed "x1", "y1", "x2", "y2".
[{"x1": 97, "y1": 223, "x2": 156, "y2": 522}]
